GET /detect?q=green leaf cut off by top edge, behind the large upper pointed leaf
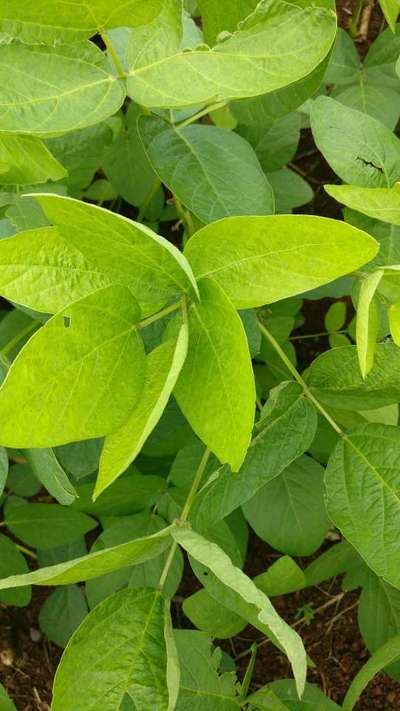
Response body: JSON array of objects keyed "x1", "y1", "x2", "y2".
[{"x1": 197, "y1": 0, "x2": 257, "y2": 47}]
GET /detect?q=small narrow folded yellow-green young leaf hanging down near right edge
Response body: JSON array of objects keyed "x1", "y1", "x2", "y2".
[{"x1": 356, "y1": 269, "x2": 384, "y2": 378}]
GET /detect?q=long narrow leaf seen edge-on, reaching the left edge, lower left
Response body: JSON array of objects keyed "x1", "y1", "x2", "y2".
[{"x1": 0, "y1": 524, "x2": 172, "y2": 596}]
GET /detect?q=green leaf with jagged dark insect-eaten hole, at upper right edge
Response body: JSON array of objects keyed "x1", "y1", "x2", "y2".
[{"x1": 311, "y1": 96, "x2": 400, "y2": 188}]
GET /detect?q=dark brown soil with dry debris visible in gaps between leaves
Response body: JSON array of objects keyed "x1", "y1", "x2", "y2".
[{"x1": 0, "y1": 0, "x2": 400, "y2": 711}]
